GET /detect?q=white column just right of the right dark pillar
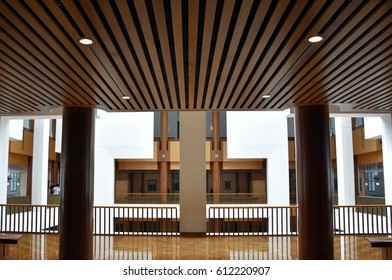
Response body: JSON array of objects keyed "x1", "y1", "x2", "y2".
[{"x1": 335, "y1": 117, "x2": 355, "y2": 205}]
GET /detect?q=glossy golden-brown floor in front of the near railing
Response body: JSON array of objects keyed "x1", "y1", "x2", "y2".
[{"x1": 6, "y1": 234, "x2": 381, "y2": 260}]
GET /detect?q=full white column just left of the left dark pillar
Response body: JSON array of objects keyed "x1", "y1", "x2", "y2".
[{"x1": 31, "y1": 119, "x2": 49, "y2": 205}]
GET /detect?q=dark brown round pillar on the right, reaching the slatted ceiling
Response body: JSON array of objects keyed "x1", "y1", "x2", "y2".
[{"x1": 295, "y1": 105, "x2": 334, "y2": 260}]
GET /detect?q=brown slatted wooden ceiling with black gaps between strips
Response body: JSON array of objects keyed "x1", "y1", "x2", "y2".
[{"x1": 0, "y1": 0, "x2": 392, "y2": 114}]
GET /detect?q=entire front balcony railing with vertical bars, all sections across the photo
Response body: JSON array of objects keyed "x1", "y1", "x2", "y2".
[{"x1": 0, "y1": 204, "x2": 392, "y2": 236}]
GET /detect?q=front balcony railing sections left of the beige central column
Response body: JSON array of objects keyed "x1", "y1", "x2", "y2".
[{"x1": 0, "y1": 204, "x2": 179, "y2": 235}]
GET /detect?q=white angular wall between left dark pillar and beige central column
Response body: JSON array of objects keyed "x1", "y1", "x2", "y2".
[{"x1": 94, "y1": 111, "x2": 154, "y2": 205}]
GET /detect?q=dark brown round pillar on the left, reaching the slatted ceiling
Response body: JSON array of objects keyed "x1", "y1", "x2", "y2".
[{"x1": 60, "y1": 107, "x2": 96, "y2": 260}]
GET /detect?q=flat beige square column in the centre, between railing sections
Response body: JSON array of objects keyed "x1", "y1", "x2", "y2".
[{"x1": 180, "y1": 112, "x2": 207, "y2": 233}]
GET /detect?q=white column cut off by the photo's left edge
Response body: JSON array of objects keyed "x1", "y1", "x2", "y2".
[{"x1": 0, "y1": 117, "x2": 9, "y2": 204}]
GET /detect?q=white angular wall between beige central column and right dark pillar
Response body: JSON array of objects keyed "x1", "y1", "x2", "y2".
[{"x1": 227, "y1": 111, "x2": 290, "y2": 205}]
